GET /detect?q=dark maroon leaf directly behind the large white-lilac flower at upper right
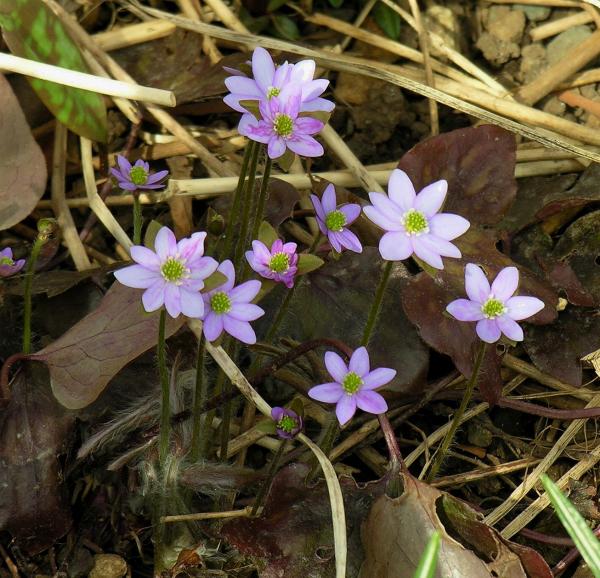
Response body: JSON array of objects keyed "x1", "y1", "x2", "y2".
[{"x1": 398, "y1": 125, "x2": 517, "y2": 225}]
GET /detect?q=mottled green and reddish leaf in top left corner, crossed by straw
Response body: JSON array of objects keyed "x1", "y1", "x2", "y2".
[{"x1": 0, "y1": 0, "x2": 107, "y2": 142}]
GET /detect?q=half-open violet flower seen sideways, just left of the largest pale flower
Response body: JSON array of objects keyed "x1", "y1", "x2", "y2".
[{"x1": 310, "y1": 184, "x2": 362, "y2": 253}]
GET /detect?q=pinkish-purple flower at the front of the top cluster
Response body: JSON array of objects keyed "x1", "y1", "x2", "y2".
[{"x1": 238, "y1": 84, "x2": 324, "y2": 159}]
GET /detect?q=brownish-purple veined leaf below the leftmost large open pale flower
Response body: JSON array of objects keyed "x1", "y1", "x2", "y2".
[{"x1": 31, "y1": 283, "x2": 184, "y2": 409}]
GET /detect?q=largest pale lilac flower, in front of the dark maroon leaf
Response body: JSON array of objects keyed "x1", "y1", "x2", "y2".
[{"x1": 363, "y1": 169, "x2": 470, "y2": 269}]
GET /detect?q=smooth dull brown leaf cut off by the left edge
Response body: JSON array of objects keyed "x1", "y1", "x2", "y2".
[{"x1": 0, "y1": 74, "x2": 47, "y2": 230}]
